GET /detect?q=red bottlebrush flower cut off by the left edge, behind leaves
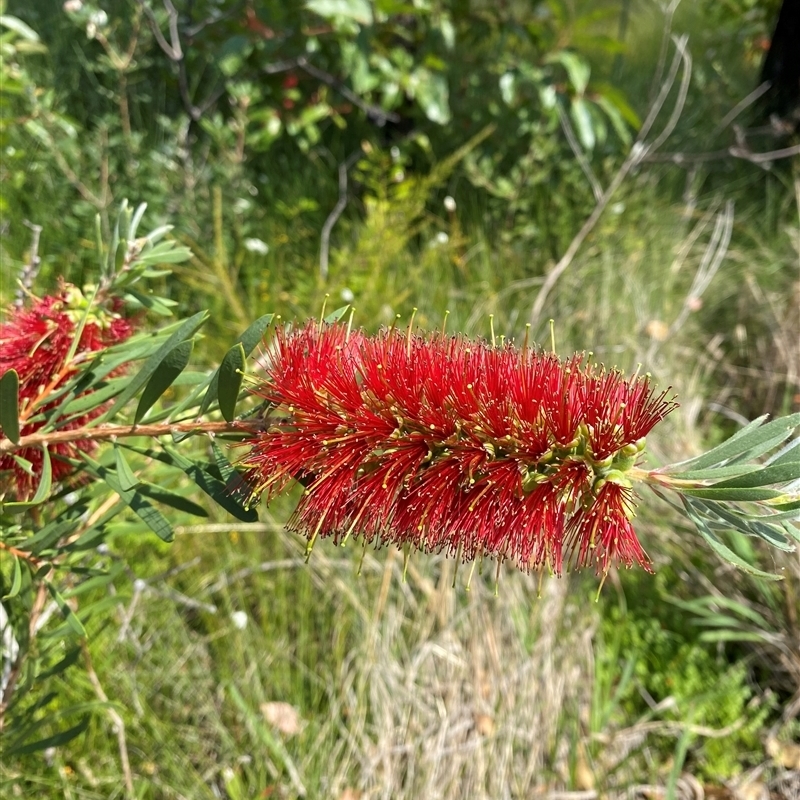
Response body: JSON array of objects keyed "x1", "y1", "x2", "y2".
[{"x1": 0, "y1": 283, "x2": 133, "y2": 500}]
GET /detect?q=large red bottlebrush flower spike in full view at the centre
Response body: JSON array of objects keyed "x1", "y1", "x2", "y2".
[{"x1": 243, "y1": 322, "x2": 675, "y2": 574}]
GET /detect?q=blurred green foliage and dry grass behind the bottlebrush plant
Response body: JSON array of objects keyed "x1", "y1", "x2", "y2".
[{"x1": 0, "y1": 0, "x2": 800, "y2": 800}]
